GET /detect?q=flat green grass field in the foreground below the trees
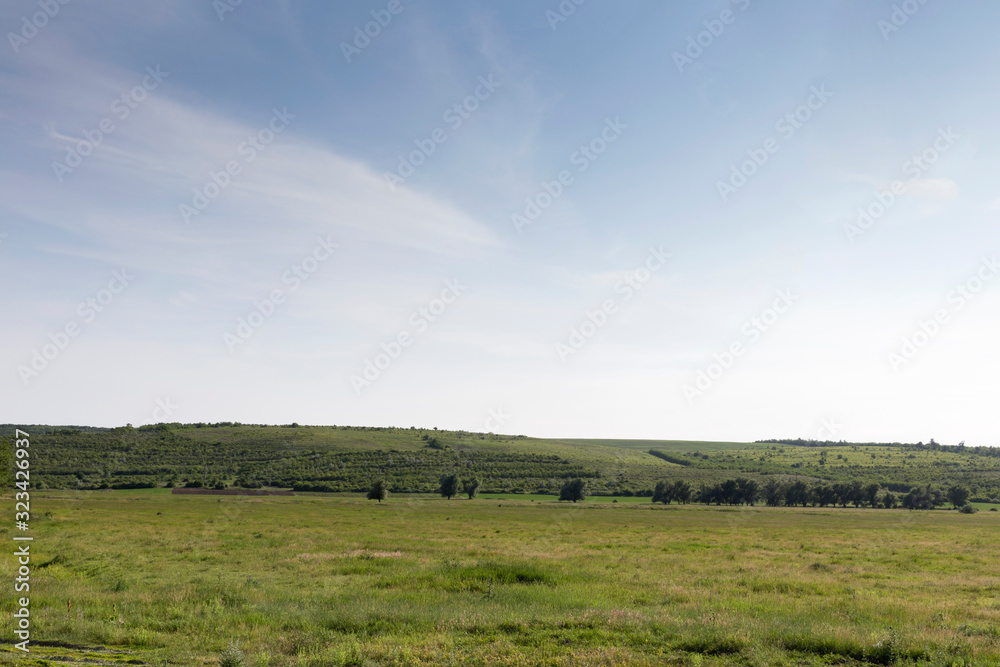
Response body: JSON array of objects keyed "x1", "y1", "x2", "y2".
[{"x1": 0, "y1": 490, "x2": 1000, "y2": 666}]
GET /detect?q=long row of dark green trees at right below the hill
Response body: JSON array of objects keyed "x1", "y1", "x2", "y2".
[{"x1": 653, "y1": 477, "x2": 969, "y2": 509}]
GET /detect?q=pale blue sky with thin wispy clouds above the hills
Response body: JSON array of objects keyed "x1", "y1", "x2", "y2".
[{"x1": 0, "y1": 0, "x2": 1000, "y2": 445}]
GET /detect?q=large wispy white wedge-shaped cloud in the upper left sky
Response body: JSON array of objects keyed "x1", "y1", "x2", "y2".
[{"x1": 0, "y1": 46, "x2": 500, "y2": 292}]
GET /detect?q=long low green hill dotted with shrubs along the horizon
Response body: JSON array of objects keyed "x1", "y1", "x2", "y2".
[{"x1": 0, "y1": 423, "x2": 1000, "y2": 499}]
